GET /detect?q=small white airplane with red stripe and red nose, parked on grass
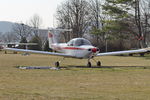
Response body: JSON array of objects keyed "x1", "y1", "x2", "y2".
[{"x1": 3, "y1": 31, "x2": 150, "y2": 67}]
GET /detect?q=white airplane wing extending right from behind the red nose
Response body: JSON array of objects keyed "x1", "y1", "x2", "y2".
[{"x1": 96, "y1": 48, "x2": 150, "y2": 56}]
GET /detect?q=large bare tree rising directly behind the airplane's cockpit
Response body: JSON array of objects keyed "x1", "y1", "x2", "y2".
[{"x1": 57, "y1": 0, "x2": 91, "y2": 37}]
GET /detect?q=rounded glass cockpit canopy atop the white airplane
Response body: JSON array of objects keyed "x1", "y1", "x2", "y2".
[{"x1": 67, "y1": 38, "x2": 91, "y2": 46}]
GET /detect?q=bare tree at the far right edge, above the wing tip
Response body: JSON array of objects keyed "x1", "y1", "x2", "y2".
[{"x1": 127, "y1": 0, "x2": 150, "y2": 48}]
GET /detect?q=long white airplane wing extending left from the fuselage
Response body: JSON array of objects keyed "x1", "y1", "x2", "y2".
[{"x1": 3, "y1": 48, "x2": 73, "y2": 57}]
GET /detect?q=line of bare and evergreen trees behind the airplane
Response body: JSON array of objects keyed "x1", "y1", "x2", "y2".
[{"x1": 0, "y1": 0, "x2": 150, "y2": 52}]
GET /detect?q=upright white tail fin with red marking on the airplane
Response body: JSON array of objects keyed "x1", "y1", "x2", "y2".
[{"x1": 48, "y1": 31, "x2": 57, "y2": 48}]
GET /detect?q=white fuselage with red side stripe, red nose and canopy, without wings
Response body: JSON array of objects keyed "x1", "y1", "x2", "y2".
[{"x1": 51, "y1": 38, "x2": 99, "y2": 59}]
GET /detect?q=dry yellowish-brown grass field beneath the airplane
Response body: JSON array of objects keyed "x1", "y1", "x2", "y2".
[{"x1": 0, "y1": 53, "x2": 150, "y2": 100}]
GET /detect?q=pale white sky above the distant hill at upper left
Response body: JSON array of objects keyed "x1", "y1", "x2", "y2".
[{"x1": 0, "y1": 0, "x2": 65, "y2": 28}]
